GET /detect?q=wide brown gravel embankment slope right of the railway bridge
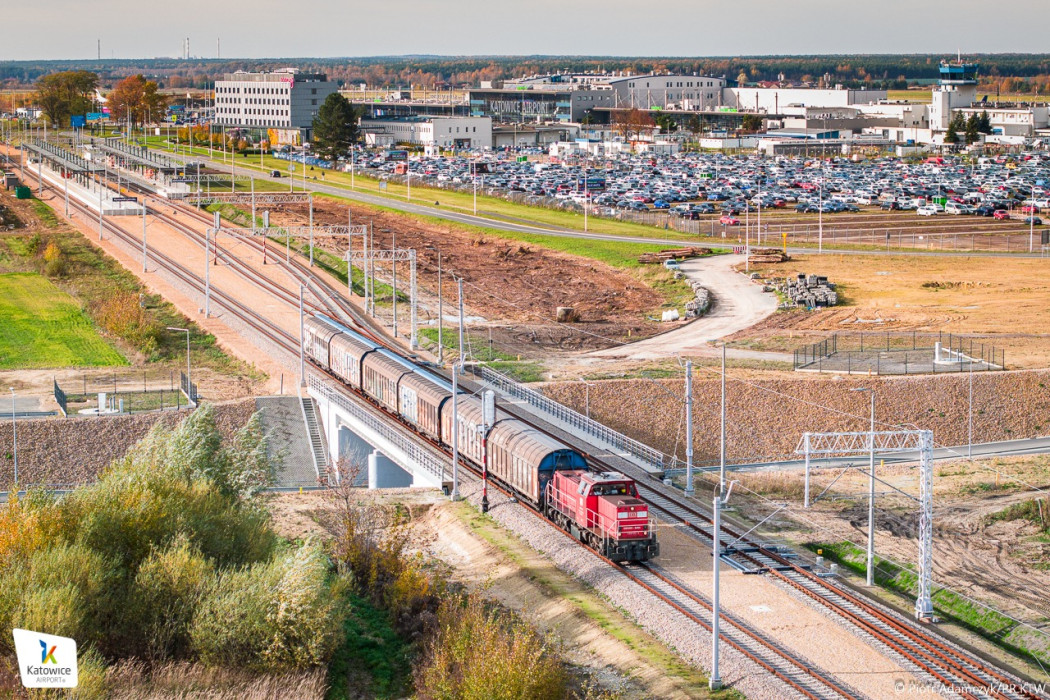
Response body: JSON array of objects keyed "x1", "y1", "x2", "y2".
[{"x1": 542, "y1": 370, "x2": 1050, "y2": 462}]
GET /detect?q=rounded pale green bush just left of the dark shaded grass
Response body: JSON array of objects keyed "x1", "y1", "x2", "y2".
[{"x1": 190, "y1": 543, "x2": 341, "y2": 671}]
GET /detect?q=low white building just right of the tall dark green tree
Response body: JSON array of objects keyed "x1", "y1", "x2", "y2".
[{"x1": 360, "y1": 116, "x2": 492, "y2": 150}]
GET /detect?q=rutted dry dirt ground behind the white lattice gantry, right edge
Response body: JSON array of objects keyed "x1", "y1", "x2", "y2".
[{"x1": 737, "y1": 455, "x2": 1050, "y2": 680}]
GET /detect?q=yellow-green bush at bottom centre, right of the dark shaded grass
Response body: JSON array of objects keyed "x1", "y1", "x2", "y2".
[{"x1": 416, "y1": 594, "x2": 569, "y2": 700}]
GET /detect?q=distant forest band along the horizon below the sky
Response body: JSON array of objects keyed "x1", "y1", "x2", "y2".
[{"x1": 6, "y1": 54, "x2": 1050, "y2": 93}]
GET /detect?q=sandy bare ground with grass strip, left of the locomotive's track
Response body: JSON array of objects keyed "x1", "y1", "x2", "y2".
[{"x1": 270, "y1": 489, "x2": 707, "y2": 700}]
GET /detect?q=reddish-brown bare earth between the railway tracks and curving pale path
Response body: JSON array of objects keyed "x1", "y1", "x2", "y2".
[{"x1": 270, "y1": 197, "x2": 664, "y2": 351}]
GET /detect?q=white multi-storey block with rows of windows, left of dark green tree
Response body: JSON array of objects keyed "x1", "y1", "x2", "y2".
[{"x1": 215, "y1": 68, "x2": 337, "y2": 141}]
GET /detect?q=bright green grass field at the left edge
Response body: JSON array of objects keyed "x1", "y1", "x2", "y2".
[{"x1": 0, "y1": 273, "x2": 127, "y2": 369}]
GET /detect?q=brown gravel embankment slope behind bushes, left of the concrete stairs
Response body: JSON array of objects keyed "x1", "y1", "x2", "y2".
[{"x1": 0, "y1": 399, "x2": 255, "y2": 488}]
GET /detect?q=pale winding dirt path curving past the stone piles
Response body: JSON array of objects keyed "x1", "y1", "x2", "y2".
[{"x1": 590, "y1": 255, "x2": 791, "y2": 362}]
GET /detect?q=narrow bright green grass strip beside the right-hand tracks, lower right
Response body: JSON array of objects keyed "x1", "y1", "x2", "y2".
[{"x1": 806, "y1": 543, "x2": 1050, "y2": 665}]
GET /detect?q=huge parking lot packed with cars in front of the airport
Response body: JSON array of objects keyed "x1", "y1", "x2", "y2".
[{"x1": 319, "y1": 146, "x2": 1050, "y2": 251}]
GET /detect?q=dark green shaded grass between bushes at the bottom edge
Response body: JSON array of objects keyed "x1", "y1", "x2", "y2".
[{"x1": 327, "y1": 593, "x2": 412, "y2": 700}]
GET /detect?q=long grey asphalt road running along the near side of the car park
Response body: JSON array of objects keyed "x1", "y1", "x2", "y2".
[{"x1": 165, "y1": 153, "x2": 1041, "y2": 257}]
